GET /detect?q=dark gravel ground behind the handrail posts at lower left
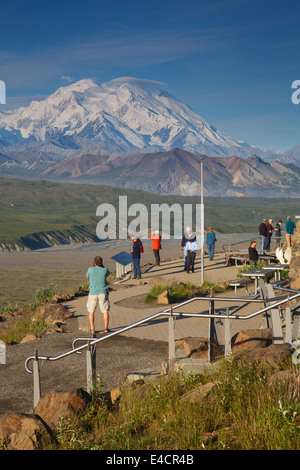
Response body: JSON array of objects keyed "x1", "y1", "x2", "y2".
[{"x1": 0, "y1": 317, "x2": 167, "y2": 415}]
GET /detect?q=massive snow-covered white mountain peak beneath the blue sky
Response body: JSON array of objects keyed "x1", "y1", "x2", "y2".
[{"x1": 0, "y1": 78, "x2": 256, "y2": 156}]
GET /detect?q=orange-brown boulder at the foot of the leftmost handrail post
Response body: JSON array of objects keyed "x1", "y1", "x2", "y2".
[{"x1": 32, "y1": 388, "x2": 91, "y2": 428}]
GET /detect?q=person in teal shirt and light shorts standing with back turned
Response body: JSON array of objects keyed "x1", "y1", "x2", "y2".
[{"x1": 86, "y1": 256, "x2": 110, "y2": 337}]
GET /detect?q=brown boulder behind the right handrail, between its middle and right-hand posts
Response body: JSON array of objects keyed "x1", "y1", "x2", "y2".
[{"x1": 231, "y1": 328, "x2": 272, "y2": 353}]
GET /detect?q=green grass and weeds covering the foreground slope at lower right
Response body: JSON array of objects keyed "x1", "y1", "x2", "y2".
[{"x1": 50, "y1": 359, "x2": 300, "y2": 451}]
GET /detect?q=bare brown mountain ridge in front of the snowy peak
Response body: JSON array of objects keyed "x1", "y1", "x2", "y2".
[{"x1": 41, "y1": 149, "x2": 300, "y2": 197}]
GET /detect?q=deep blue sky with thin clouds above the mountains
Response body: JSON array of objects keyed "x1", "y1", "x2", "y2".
[{"x1": 0, "y1": 0, "x2": 300, "y2": 151}]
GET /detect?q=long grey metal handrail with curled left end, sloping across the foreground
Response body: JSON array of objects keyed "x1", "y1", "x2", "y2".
[{"x1": 25, "y1": 291, "x2": 300, "y2": 374}]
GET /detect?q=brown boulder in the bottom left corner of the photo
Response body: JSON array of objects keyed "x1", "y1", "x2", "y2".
[{"x1": 0, "y1": 413, "x2": 54, "y2": 450}]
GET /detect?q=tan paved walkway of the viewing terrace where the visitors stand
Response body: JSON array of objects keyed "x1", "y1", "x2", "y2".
[{"x1": 67, "y1": 254, "x2": 262, "y2": 342}]
